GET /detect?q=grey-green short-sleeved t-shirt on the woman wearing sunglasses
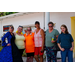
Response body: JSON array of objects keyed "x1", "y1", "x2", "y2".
[{"x1": 45, "y1": 29, "x2": 59, "y2": 47}]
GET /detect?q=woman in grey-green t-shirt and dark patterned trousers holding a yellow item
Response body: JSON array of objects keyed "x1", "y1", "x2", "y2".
[{"x1": 45, "y1": 22, "x2": 59, "y2": 62}]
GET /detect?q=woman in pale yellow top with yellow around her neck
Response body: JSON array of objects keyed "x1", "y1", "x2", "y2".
[{"x1": 15, "y1": 26, "x2": 25, "y2": 57}]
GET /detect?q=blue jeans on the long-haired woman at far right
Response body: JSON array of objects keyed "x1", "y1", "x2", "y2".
[{"x1": 61, "y1": 49, "x2": 73, "y2": 62}]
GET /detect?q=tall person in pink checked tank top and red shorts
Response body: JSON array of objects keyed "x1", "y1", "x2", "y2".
[{"x1": 34, "y1": 21, "x2": 45, "y2": 62}]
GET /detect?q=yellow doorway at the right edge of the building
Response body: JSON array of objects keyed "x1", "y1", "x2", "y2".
[{"x1": 71, "y1": 16, "x2": 75, "y2": 58}]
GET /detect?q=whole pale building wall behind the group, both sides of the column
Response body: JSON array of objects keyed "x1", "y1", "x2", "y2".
[{"x1": 0, "y1": 12, "x2": 75, "y2": 37}]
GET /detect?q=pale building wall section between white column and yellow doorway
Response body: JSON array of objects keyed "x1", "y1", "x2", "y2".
[{"x1": 50, "y1": 12, "x2": 75, "y2": 33}]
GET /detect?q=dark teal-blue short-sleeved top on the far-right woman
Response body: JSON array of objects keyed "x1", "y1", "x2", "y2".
[{"x1": 57, "y1": 33, "x2": 74, "y2": 48}]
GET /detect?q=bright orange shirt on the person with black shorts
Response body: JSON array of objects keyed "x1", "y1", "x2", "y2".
[{"x1": 24, "y1": 33, "x2": 35, "y2": 53}]
